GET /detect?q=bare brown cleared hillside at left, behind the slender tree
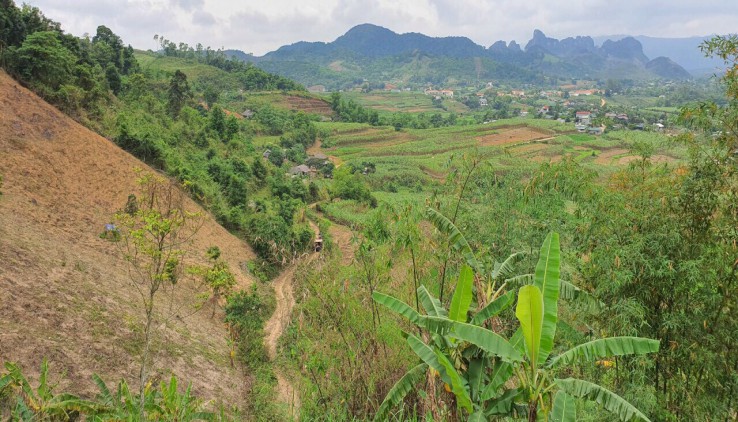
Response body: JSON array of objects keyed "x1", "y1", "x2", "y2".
[{"x1": 0, "y1": 71, "x2": 254, "y2": 404}]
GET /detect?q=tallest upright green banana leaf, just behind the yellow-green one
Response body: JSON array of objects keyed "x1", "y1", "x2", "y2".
[{"x1": 533, "y1": 232, "x2": 560, "y2": 365}]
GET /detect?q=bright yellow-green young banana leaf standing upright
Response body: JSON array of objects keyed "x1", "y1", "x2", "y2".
[{"x1": 515, "y1": 284, "x2": 543, "y2": 368}]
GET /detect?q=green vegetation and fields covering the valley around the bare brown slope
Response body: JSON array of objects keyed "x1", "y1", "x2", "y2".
[{"x1": 0, "y1": 0, "x2": 738, "y2": 420}]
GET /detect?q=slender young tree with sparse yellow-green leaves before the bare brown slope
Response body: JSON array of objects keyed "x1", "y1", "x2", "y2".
[{"x1": 110, "y1": 174, "x2": 202, "y2": 420}]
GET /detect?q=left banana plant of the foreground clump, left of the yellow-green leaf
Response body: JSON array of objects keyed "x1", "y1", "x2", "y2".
[{"x1": 373, "y1": 265, "x2": 523, "y2": 420}]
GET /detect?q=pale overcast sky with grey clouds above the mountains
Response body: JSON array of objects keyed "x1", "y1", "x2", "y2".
[{"x1": 23, "y1": 0, "x2": 738, "y2": 55}]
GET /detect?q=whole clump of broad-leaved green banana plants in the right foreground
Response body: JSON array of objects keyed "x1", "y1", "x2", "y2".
[{"x1": 374, "y1": 233, "x2": 659, "y2": 422}]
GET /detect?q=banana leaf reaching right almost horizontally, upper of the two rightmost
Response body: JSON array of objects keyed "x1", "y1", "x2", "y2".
[{"x1": 548, "y1": 337, "x2": 659, "y2": 367}]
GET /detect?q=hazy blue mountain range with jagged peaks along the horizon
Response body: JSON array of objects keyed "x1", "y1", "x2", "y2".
[{"x1": 226, "y1": 24, "x2": 719, "y2": 89}]
